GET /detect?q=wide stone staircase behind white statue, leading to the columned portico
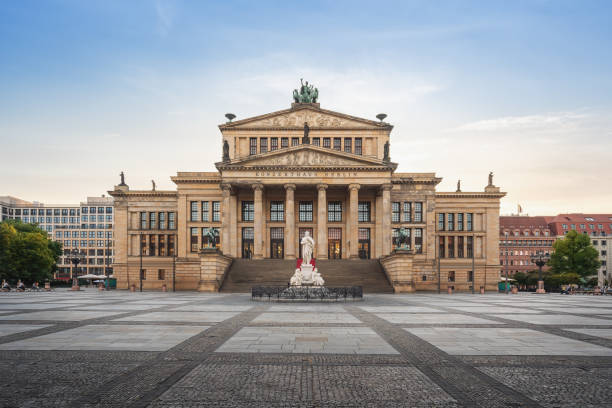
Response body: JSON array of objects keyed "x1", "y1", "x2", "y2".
[{"x1": 221, "y1": 259, "x2": 393, "y2": 293}]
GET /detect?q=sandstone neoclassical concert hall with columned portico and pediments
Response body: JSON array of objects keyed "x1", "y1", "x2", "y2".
[{"x1": 109, "y1": 82, "x2": 505, "y2": 293}]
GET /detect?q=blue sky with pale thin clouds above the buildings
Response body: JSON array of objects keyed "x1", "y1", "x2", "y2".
[{"x1": 0, "y1": 0, "x2": 612, "y2": 215}]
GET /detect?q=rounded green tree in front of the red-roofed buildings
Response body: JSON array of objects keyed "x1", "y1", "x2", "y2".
[{"x1": 548, "y1": 230, "x2": 599, "y2": 278}]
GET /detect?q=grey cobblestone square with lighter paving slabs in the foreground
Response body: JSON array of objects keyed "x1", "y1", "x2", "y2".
[{"x1": 0, "y1": 290, "x2": 612, "y2": 408}]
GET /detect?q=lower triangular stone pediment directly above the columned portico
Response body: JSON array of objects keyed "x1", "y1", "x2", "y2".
[{"x1": 217, "y1": 145, "x2": 396, "y2": 170}]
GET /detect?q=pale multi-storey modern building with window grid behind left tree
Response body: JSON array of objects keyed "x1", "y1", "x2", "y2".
[{"x1": 0, "y1": 196, "x2": 115, "y2": 279}]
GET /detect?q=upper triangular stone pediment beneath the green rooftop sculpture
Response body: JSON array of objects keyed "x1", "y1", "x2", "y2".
[{"x1": 219, "y1": 104, "x2": 392, "y2": 130}]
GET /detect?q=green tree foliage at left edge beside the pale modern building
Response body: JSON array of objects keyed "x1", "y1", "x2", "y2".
[{"x1": 0, "y1": 220, "x2": 62, "y2": 282}]
